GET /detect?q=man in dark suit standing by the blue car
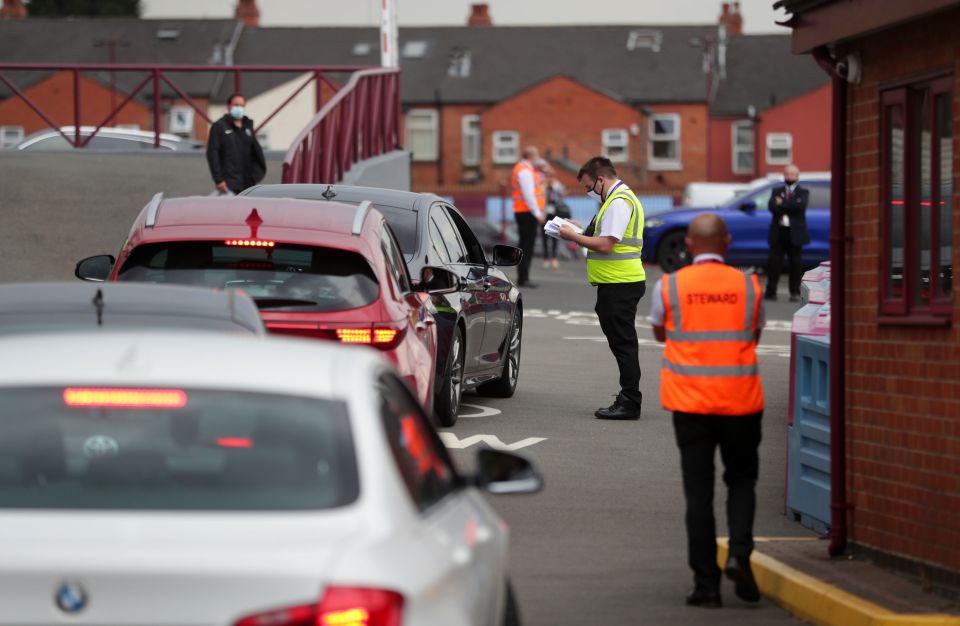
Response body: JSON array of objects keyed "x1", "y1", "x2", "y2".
[{"x1": 764, "y1": 165, "x2": 810, "y2": 302}]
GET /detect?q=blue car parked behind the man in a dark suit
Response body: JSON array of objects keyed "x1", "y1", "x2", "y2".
[{"x1": 643, "y1": 180, "x2": 830, "y2": 272}]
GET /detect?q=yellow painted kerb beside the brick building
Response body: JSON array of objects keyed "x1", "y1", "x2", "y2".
[{"x1": 717, "y1": 537, "x2": 960, "y2": 626}]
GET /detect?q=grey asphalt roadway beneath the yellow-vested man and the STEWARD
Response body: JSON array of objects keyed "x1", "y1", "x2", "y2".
[{"x1": 441, "y1": 259, "x2": 811, "y2": 626}]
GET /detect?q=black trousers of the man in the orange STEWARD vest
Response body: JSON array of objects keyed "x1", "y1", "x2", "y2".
[{"x1": 673, "y1": 411, "x2": 763, "y2": 591}]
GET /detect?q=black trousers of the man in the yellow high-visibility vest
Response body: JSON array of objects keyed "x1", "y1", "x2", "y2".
[{"x1": 594, "y1": 280, "x2": 647, "y2": 408}]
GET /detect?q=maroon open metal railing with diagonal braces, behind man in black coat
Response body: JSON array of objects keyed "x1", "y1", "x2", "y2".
[{"x1": 0, "y1": 63, "x2": 376, "y2": 149}]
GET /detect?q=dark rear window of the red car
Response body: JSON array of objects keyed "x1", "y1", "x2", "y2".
[{"x1": 119, "y1": 240, "x2": 380, "y2": 312}]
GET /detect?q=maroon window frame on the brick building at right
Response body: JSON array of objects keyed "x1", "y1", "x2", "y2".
[{"x1": 878, "y1": 74, "x2": 956, "y2": 326}]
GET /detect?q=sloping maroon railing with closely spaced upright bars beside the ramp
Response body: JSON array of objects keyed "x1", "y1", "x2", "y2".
[{"x1": 283, "y1": 68, "x2": 400, "y2": 183}]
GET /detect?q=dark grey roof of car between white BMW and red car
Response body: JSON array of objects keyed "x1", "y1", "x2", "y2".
[{"x1": 0, "y1": 282, "x2": 262, "y2": 330}]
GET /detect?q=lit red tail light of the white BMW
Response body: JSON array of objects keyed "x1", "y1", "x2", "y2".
[{"x1": 234, "y1": 587, "x2": 403, "y2": 626}]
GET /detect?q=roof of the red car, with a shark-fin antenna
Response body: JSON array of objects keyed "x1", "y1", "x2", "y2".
[{"x1": 147, "y1": 196, "x2": 372, "y2": 236}]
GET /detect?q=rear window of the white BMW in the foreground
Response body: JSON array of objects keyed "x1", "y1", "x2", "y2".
[{"x1": 0, "y1": 386, "x2": 359, "y2": 511}]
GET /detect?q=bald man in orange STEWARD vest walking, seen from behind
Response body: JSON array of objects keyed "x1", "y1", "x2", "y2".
[{"x1": 650, "y1": 213, "x2": 764, "y2": 607}]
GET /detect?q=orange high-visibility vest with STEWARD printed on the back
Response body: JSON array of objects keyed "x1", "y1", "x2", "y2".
[{"x1": 660, "y1": 262, "x2": 763, "y2": 415}]
